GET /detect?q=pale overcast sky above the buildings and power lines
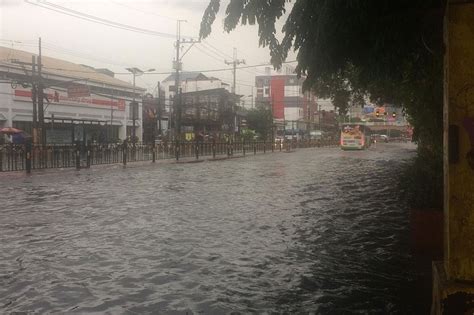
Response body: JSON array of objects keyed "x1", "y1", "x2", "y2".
[{"x1": 0, "y1": 0, "x2": 294, "y2": 106}]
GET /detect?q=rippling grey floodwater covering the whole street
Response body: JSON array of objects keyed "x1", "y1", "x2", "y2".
[{"x1": 0, "y1": 144, "x2": 414, "y2": 314}]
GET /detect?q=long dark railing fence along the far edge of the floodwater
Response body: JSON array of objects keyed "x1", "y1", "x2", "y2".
[{"x1": 0, "y1": 140, "x2": 337, "y2": 172}]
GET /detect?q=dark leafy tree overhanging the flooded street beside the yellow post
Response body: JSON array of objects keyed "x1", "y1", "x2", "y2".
[{"x1": 200, "y1": 0, "x2": 445, "y2": 148}]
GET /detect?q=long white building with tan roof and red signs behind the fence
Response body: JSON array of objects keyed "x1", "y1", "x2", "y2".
[{"x1": 0, "y1": 47, "x2": 145, "y2": 143}]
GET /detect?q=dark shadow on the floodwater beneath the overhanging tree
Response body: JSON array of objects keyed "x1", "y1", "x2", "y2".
[{"x1": 270, "y1": 152, "x2": 419, "y2": 314}]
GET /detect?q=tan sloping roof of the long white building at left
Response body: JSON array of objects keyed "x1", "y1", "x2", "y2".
[{"x1": 0, "y1": 46, "x2": 146, "y2": 91}]
